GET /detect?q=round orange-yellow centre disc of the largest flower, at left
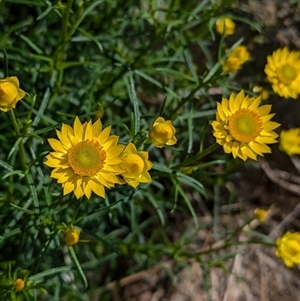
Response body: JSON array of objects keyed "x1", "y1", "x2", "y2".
[{"x1": 68, "y1": 140, "x2": 106, "y2": 177}]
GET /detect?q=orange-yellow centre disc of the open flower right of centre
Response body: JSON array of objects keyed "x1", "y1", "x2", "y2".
[{"x1": 229, "y1": 109, "x2": 262, "y2": 143}]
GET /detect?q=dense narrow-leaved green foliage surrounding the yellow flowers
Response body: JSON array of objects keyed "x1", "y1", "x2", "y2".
[{"x1": 0, "y1": 0, "x2": 282, "y2": 300}]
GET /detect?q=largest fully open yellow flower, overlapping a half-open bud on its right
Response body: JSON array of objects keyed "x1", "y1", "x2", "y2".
[{"x1": 45, "y1": 117, "x2": 124, "y2": 199}]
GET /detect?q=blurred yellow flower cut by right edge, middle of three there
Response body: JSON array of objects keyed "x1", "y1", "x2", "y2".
[{"x1": 279, "y1": 128, "x2": 300, "y2": 156}]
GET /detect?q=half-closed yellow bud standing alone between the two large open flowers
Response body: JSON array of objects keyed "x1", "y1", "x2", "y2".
[{"x1": 147, "y1": 117, "x2": 177, "y2": 148}]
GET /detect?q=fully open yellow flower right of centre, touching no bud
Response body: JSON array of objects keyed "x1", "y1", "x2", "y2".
[{"x1": 212, "y1": 90, "x2": 280, "y2": 161}]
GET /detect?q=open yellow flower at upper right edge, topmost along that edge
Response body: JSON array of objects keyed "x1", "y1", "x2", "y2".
[{"x1": 265, "y1": 47, "x2": 300, "y2": 99}]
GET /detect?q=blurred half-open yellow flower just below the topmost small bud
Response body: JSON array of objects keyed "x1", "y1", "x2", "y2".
[{"x1": 222, "y1": 45, "x2": 250, "y2": 73}]
